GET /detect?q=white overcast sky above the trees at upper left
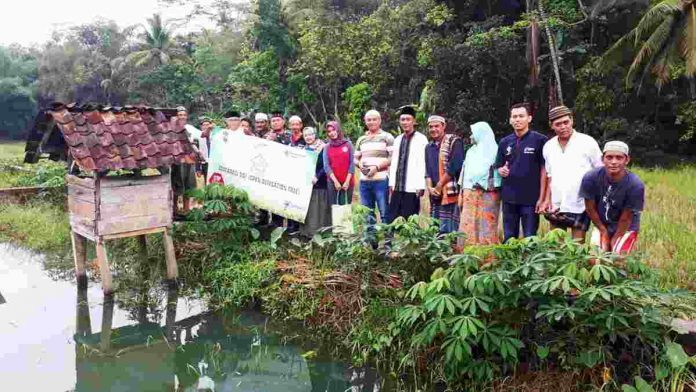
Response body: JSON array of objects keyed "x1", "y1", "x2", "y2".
[{"x1": 0, "y1": 0, "x2": 248, "y2": 46}]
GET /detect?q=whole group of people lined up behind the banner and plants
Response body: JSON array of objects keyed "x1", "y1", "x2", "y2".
[{"x1": 173, "y1": 103, "x2": 645, "y2": 254}]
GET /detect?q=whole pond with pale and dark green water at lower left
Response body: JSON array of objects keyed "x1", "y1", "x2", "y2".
[{"x1": 0, "y1": 244, "x2": 380, "y2": 392}]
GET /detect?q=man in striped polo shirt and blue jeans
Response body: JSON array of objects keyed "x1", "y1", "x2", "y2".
[{"x1": 355, "y1": 110, "x2": 394, "y2": 234}]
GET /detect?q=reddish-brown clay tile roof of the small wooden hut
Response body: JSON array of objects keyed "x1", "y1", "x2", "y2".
[{"x1": 48, "y1": 104, "x2": 196, "y2": 171}]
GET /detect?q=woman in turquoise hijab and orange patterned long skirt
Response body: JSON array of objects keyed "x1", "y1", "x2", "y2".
[{"x1": 459, "y1": 122, "x2": 501, "y2": 246}]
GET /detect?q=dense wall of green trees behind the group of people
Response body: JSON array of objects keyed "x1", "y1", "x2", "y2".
[{"x1": 0, "y1": 0, "x2": 696, "y2": 164}]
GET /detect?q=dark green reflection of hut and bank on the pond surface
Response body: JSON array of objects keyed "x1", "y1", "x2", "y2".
[{"x1": 75, "y1": 289, "x2": 362, "y2": 392}]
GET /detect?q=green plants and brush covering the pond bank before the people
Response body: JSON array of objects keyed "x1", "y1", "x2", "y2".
[{"x1": 170, "y1": 185, "x2": 696, "y2": 391}]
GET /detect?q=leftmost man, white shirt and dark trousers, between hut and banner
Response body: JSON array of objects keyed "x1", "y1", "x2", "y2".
[{"x1": 171, "y1": 106, "x2": 205, "y2": 218}]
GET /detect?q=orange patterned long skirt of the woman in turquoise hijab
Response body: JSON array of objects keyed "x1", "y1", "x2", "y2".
[{"x1": 459, "y1": 189, "x2": 500, "y2": 245}]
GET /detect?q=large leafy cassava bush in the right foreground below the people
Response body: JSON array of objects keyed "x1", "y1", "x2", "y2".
[{"x1": 390, "y1": 231, "x2": 696, "y2": 384}]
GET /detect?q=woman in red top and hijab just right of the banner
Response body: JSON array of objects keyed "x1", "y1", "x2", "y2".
[{"x1": 323, "y1": 121, "x2": 355, "y2": 205}]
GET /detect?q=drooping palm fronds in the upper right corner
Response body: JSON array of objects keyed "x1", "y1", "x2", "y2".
[{"x1": 604, "y1": 0, "x2": 696, "y2": 95}]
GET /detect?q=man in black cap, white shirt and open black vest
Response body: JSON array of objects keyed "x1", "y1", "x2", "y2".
[{"x1": 389, "y1": 106, "x2": 428, "y2": 222}]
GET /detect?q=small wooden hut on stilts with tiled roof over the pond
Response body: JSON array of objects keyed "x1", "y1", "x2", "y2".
[{"x1": 26, "y1": 103, "x2": 196, "y2": 294}]
